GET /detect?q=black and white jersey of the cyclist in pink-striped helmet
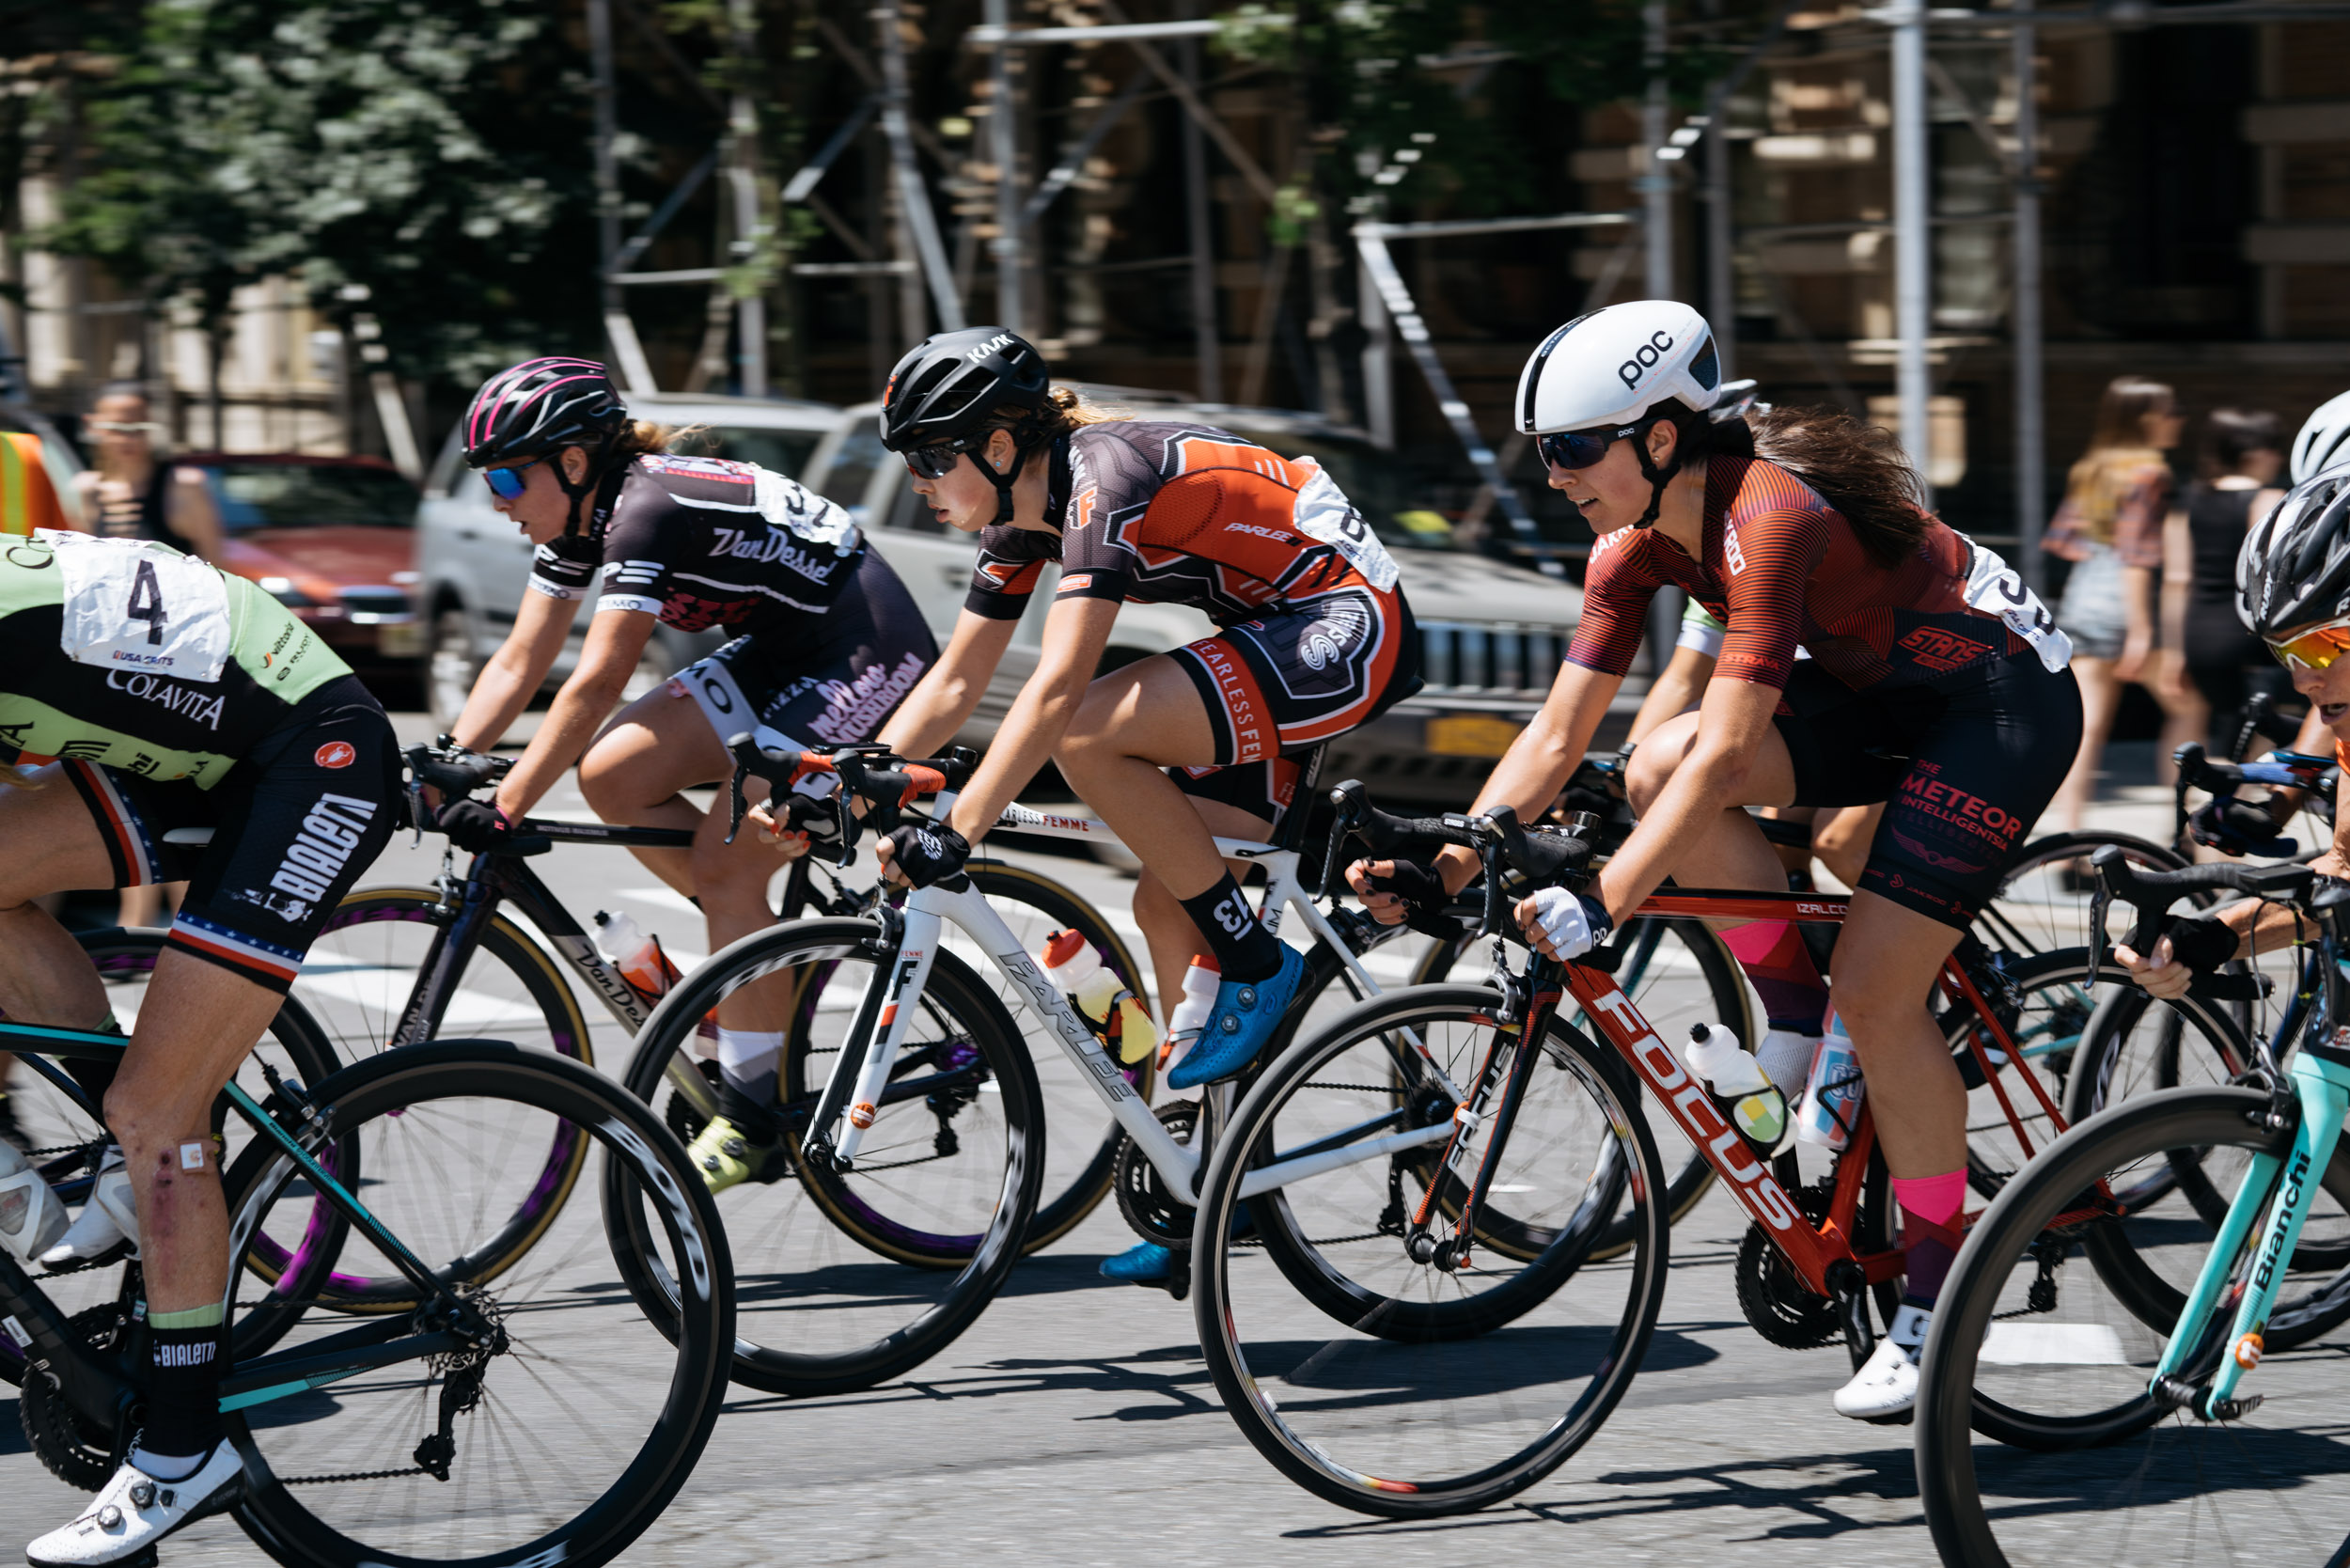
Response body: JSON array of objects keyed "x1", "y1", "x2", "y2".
[{"x1": 531, "y1": 456, "x2": 886, "y2": 642}]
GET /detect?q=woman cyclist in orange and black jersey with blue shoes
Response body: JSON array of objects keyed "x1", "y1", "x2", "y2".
[{"x1": 882, "y1": 327, "x2": 1419, "y2": 1114}]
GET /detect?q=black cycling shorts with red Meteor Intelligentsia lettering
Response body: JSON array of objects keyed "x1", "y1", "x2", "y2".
[{"x1": 1777, "y1": 649, "x2": 2080, "y2": 931}]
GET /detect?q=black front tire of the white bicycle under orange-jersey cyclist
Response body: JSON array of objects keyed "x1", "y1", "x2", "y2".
[{"x1": 620, "y1": 919, "x2": 1043, "y2": 1394}]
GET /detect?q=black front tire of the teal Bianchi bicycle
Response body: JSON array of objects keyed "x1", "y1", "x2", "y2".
[{"x1": 1916, "y1": 1089, "x2": 2350, "y2": 1568}]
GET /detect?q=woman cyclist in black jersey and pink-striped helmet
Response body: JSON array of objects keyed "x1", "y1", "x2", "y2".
[{"x1": 440, "y1": 357, "x2": 938, "y2": 1189}]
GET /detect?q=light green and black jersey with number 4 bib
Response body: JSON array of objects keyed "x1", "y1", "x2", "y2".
[{"x1": 0, "y1": 531, "x2": 351, "y2": 790}]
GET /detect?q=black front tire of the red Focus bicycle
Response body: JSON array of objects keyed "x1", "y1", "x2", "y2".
[{"x1": 1192, "y1": 985, "x2": 1671, "y2": 1518}]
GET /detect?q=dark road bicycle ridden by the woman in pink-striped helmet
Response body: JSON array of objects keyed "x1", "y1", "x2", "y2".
[{"x1": 274, "y1": 738, "x2": 1154, "y2": 1311}]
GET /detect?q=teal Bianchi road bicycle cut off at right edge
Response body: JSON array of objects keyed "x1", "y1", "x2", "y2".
[{"x1": 1916, "y1": 865, "x2": 2350, "y2": 1568}]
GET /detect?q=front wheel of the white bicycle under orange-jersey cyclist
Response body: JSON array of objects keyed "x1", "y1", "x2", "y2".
[{"x1": 623, "y1": 919, "x2": 1043, "y2": 1394}]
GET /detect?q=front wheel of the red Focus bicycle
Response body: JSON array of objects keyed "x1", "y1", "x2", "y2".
[{"x1": 1192, "y1": 985, "x2": 1668, "y2": 1518}]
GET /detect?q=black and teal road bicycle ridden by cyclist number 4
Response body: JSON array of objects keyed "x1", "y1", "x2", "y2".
[{"x1": 0, "y1": 1025, "x2": 733, "y2": 1568}]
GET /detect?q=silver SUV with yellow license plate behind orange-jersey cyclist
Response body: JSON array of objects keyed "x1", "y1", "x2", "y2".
[{"x1": 802, "y1": 388, "x2": 1584, "y2": 807}]
